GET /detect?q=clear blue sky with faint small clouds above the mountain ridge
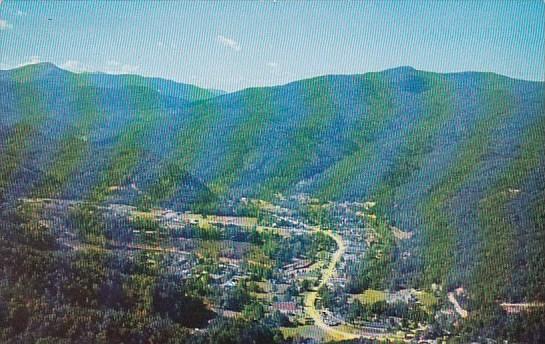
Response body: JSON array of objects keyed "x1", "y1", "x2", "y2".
[{"x1": 0, "y1": 0, "x2": 545, "y2": 91}]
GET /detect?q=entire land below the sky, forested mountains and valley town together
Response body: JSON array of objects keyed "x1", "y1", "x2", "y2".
[{"x1": 0, "y1": 64, "x2": 545, "y2": 343}]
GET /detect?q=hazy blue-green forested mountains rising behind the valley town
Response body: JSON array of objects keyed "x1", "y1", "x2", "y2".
[{"x1": 0, "y1": 64, "x2": 545, "y2": 301}]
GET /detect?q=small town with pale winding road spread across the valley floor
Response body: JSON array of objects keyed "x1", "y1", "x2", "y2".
[{"x1": 5, "y1": 196, "x2": 464, "y2": 341}]
